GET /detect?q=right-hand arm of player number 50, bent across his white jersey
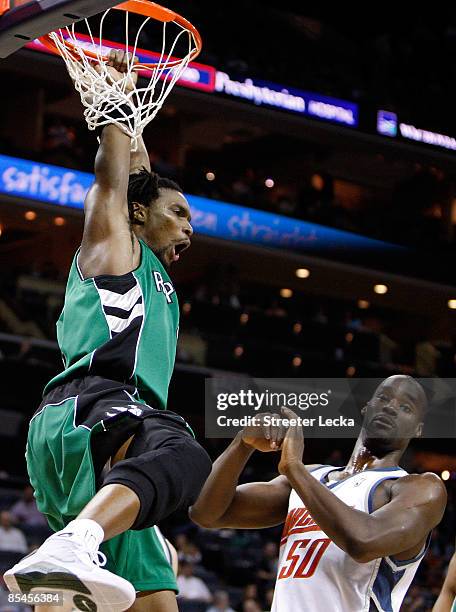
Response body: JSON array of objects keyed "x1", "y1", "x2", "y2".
[{"x1": 279, "y1": 409, "x2": 446, "y2": 563}]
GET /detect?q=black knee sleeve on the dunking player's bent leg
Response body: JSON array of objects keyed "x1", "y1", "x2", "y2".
[{"x1": 103, "y1": 436, "x2": 212, "y2": 529}]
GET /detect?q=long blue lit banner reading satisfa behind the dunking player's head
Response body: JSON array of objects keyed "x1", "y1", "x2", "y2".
[{"x1": 0, "y1": 155, "x2": 399, "y2": 252}]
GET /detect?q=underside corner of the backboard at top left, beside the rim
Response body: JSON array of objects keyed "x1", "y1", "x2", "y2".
[{"x1": 0, "y1": 0, "x2": 122, "y2": 58}]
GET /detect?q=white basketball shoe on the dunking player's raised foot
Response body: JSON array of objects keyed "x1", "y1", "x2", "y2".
[{"x1": 4, "y1": 524, "x2": 136, "y2": 612}]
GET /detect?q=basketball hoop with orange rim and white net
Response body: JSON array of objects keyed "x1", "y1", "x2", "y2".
[{"x1": 39, "y1": 0, "x2": 202, "y2": 150}]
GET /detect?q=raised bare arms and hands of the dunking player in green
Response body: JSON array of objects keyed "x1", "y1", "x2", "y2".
[{"x1": 79, "y1": 51, "x2": 141, "y2": 278}]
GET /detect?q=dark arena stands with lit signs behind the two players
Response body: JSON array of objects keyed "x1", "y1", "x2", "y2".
[{"x1": 0, "y1": 0, "x2": 456, "y2": 612}]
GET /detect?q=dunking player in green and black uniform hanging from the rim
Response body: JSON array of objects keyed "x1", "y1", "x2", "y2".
[{"x1": 5, "y1": 51, "x2": 211, "y2": 612}]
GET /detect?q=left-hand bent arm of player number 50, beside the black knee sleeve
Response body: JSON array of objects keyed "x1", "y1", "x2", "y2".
[{"x1": 190, "y1": 416, "x2": 290, "y2": 529}]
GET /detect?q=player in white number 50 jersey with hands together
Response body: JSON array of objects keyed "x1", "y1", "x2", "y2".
[{"x1": 190, "y1": 376, "x2": 446, "y2": 612}]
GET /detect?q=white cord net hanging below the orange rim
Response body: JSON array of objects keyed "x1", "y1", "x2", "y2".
[{"x1": 50, "y1": 9, "x2": 196, "y2": 150}]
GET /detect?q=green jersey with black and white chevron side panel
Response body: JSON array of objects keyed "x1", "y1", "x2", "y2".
[{"x1": 44, "y1": 241, "x2": 179, "y2": 408}]
